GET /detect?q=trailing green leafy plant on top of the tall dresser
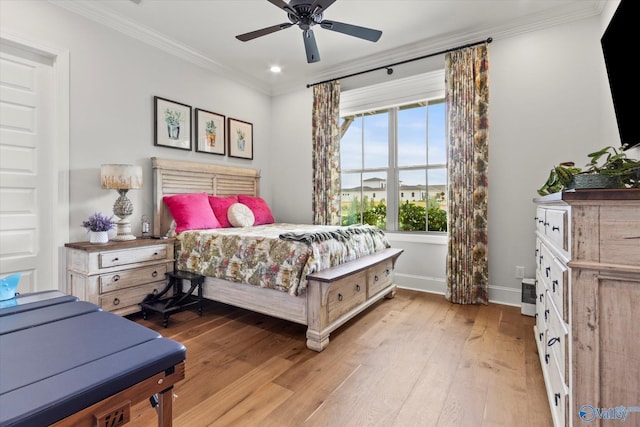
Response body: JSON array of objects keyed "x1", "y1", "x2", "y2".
[{"x1": 538, "y1": 146, "x2": 640, "y2": 196}]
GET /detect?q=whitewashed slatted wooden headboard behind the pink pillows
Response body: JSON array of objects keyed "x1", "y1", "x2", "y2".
[{"x1": 151, "y1": 157, "x2": 260, "y2": 236}]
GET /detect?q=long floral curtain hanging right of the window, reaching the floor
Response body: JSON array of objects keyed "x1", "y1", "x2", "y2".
[{"x1": 445, "y1": 43, "x2": 489, "y2": 304}]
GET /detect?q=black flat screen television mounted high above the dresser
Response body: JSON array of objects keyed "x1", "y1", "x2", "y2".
[{"x1": 600, "y1": 0, "x2": 640, "y2": 149}]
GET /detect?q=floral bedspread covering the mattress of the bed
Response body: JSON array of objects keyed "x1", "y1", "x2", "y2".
[{"x1": 176, "y1": 223, "x2": 389, "y2": 295}]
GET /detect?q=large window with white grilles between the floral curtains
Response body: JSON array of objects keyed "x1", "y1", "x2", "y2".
[{"x1": 340, "y1": 97, "x2": 447, "y2": 232}]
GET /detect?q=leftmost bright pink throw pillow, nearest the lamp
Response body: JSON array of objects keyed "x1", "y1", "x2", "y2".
[{"x1": 162, "y1": 193, "x2": 220, "y2": 233}]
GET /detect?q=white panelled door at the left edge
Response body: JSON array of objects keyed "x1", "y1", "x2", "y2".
[{"x1": 0, "y1": 43, "x2": 56, "y2": 293}]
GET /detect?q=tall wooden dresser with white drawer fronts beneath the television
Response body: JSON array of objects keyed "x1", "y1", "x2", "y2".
[{"x1": 534, "y1": 189, "x2": 640, "y2": 426}]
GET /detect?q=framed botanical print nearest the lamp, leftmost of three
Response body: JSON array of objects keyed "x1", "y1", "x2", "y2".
[{"x1": 153, "y1": 96, "x2": 192, "y2": 151}]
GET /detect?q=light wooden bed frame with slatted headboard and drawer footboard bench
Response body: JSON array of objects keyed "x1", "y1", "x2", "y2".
[{"x1": 151, "y1": 157, "x2": 402, "y2": 351}]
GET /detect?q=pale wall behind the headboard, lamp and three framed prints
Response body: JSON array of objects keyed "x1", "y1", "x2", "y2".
[{"x1": 0, "y1": 0, "x2": 272, "y2": 241}]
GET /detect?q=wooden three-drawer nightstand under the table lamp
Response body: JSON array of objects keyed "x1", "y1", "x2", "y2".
[{"x1": 65, "y1": 239, "x2": 174, "y2": 316}]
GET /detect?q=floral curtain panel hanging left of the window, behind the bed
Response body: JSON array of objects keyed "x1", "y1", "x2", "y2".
[{"x1": 312, "y1": 81, "x2": 340, "y2": 225}]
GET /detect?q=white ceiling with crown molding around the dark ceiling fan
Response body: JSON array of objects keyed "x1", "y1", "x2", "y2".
[{"x1": 51, "y1": 0, "x2": 611, "y2": 95}]
